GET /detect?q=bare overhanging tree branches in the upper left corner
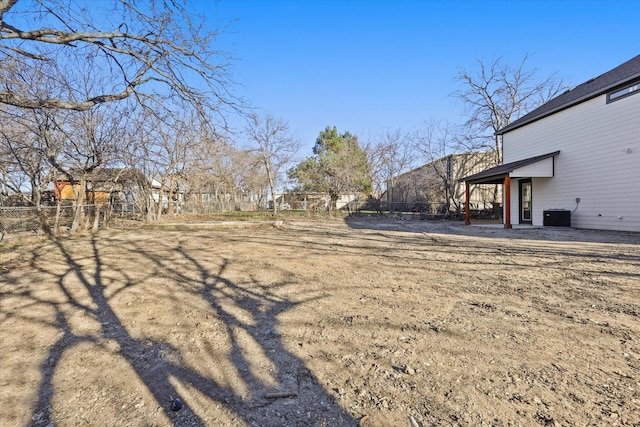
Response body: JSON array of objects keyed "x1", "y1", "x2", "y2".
[{"x1": 0, "y1": 0, "x2": 237, "y2": 114}]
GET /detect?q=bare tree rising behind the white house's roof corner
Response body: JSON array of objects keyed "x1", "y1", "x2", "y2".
[{"x1": 453, "y1": 56, "x2": 566, "y2": 164}]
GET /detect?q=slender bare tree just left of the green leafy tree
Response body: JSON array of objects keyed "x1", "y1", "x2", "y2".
[{"x1": 245, "y1": 114, "x2": 300, "y2": 215}]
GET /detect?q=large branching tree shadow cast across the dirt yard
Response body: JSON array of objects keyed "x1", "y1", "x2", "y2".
[{"x1": 20, "y1": 236, "x2": 357, "y2": 426}]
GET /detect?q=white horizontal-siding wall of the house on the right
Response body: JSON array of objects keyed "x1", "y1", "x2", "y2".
[{"x1": 503, "y1": 90, "x2": 640, "y2": 231}]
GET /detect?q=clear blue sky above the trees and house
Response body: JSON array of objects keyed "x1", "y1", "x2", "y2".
[{"x1": 212, "y1": 0, "x2": 640, "y2": 152}]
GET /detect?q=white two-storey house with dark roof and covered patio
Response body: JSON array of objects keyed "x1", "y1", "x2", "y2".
[{"x1": 462, "y1": 55, "x2": 640, "y2": 232}]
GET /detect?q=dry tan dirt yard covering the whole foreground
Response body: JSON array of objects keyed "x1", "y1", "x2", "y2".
[{"x1": 0, "y1": 219, "x2": 640, "y2": 427}]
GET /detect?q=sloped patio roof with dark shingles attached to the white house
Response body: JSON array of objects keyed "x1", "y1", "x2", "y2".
[{"x1": 458, "y1": 151, "x2": 560, "y2": 184}]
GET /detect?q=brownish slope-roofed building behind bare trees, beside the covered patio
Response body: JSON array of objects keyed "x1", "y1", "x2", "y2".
[{"x1": 381, "y1": 152, "x2": 502, "y2": 214}]
